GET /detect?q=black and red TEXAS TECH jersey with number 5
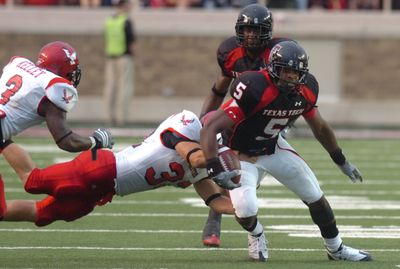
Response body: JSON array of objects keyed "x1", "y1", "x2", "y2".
[{"x1": 222, "y1": 71, "x2": 318, "y2": 156}]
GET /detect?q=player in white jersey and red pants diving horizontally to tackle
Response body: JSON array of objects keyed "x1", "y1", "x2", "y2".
[{"x1": 0, "y1": 110, "x2": 234, "y2": 226}]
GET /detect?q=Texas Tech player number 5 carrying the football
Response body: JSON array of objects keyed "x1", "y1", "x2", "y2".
[{"x1": 201, "y1": 41, "x2": 372, "y2": 261}]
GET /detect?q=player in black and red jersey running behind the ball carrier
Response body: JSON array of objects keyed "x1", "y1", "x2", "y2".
[{"x1": 200, "y1": 4, "x2": 290, "y2": 247}]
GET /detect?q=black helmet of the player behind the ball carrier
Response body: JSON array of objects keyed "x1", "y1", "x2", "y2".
[{"x1": 235, "y1": 4, "x2": 272, "y2": 49}]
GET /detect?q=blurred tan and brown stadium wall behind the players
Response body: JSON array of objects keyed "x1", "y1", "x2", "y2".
[{"x1": 0, "y1": 7, "x2": 400, "y2": 126}]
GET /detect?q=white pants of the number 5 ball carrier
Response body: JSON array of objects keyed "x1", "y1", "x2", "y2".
[{"x1": 230, "y1": 136, "x2": 323, "y2": 218}]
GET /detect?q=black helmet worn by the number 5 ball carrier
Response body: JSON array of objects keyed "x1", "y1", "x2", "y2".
[{"x1": 267, "y1": 41, "x2": 308, "y2": 93}]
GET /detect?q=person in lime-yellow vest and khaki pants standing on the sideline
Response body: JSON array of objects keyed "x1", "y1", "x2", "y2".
[{"x1": 104, "y1": 0, "x2": 135, "y2": 126}]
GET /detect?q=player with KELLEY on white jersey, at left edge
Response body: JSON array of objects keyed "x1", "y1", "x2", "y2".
[{"x1": 0, "y1": 41, "x2": 113, "y2": 200}]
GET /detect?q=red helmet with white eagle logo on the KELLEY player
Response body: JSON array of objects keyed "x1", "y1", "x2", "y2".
[{"x1": 36, "y1": 41, "x2": 81, "y2": 87}]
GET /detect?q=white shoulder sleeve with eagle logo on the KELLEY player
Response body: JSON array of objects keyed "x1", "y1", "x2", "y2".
[{"x1": 46, "y1": 77, "x2": 78, "y2": 112}]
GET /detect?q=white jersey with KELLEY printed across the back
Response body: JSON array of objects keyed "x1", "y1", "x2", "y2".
[{"x1": 0, "y1": 57, "x2": 78, "y2": 140}]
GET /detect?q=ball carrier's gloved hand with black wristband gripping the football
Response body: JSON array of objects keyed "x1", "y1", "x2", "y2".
[{"x1": 207, "y1": 158, "x2": 241, "y2": 190}]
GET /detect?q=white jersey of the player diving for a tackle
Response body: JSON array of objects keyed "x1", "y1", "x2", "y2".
[{"x1": 115, "y1": 110, "x2": 207, "y2": 195}]
